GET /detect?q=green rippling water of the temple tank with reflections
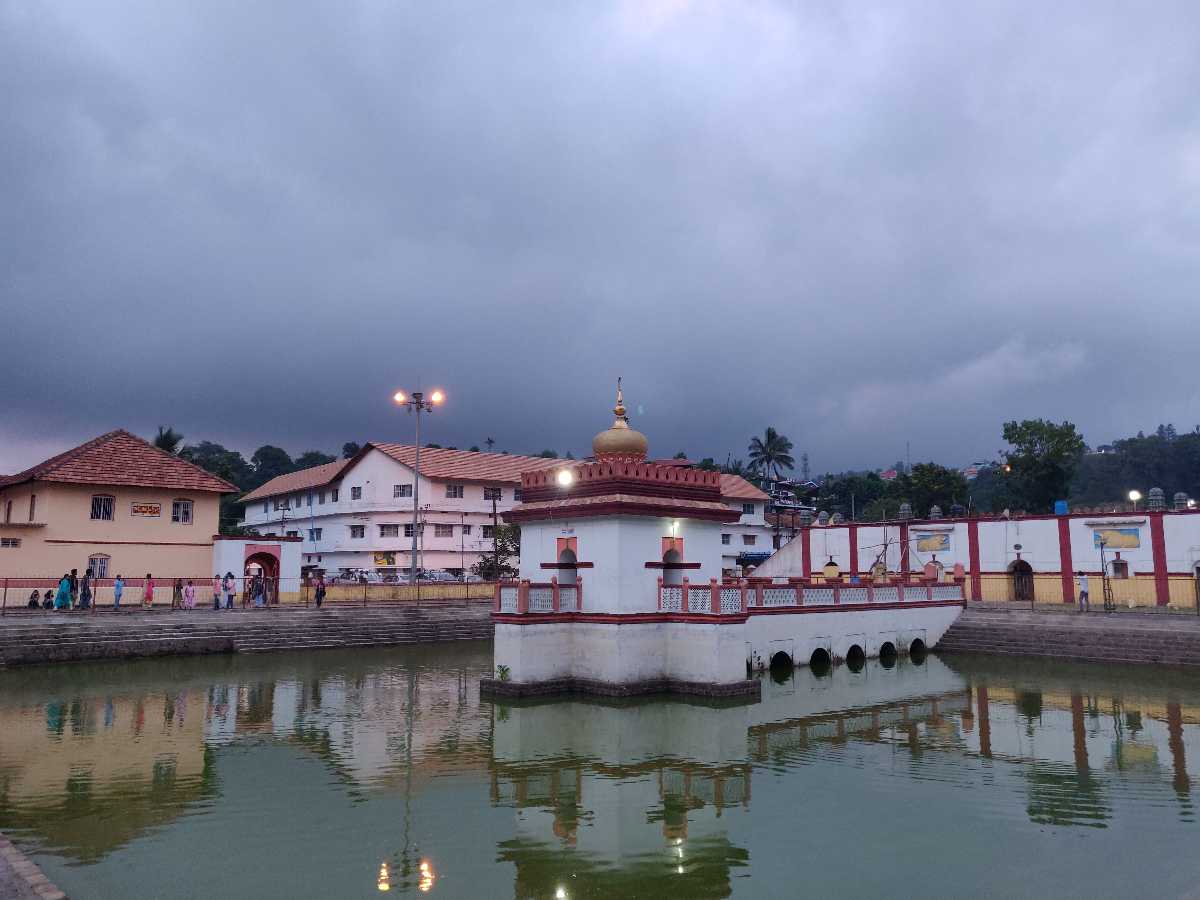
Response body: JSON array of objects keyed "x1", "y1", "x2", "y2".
[{"x1": 0, "y1": 643, "x2": 1200, "y2": 900}]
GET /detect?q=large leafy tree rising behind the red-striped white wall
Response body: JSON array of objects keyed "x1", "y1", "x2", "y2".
[{"x1": 1003, "y1": 419, "x2": 1087, "y2": 512}]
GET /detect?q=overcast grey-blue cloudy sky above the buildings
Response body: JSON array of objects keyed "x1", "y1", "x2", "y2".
[{"x1": 0, "y1": 0, "x2": 1200, "y2": 480}]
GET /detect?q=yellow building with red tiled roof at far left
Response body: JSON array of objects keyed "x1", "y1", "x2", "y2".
[{"x1": 0, "y1": 431, "x2": 238, "y2": 585}]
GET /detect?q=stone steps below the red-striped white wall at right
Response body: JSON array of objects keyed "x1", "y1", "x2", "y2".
[{"x1": 936, "y1": 607, "x2": 1200, "y2": 666}]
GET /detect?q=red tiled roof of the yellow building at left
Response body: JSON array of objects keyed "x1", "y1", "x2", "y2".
[{"x1": 0, "y1": 428, "x2": 238, "y2": 493}]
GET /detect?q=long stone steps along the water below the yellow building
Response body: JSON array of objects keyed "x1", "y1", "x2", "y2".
[{"x1": 0, "y1": 600, "x2": 493, "y2": 667}]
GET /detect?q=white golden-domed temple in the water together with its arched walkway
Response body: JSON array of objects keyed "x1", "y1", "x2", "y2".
[{"x1": 481, "y1": 380, "x2": 962, "y2": 701}]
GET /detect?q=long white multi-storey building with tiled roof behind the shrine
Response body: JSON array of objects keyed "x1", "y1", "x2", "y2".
[{"x1": 242, "y1": 443, "x2": 770, "y2": 585}]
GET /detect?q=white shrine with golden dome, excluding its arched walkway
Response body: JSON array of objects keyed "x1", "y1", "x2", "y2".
[{"x1": 481, "y1": 380, "x2": 760, "y2": 698}]
